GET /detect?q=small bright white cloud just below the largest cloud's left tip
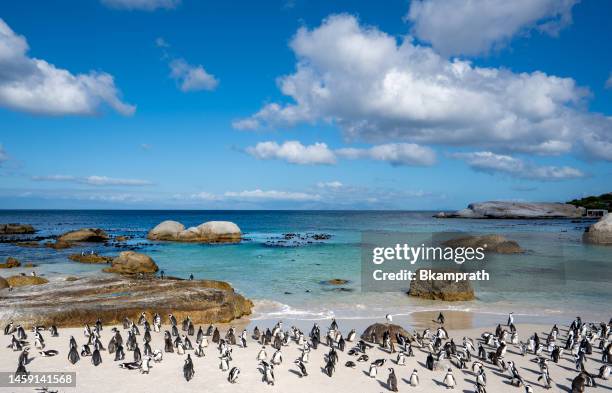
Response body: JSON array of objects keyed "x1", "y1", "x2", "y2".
[{"x1": 246, "y1": 141, "x2": 336, "y2": 164}]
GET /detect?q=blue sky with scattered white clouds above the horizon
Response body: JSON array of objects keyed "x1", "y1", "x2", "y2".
[{"x1": 0, "y1": 0, "x2": 612, "y2": 210}]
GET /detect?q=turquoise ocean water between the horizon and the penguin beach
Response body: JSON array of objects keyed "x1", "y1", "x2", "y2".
[{"x1": 0, "y1": 210, "x2": 612, "y2": 321}]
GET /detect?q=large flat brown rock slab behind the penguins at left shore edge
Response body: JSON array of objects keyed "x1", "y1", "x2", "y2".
[{"x1": 0, "y1": 276, "x2": 253, "y2": 327}]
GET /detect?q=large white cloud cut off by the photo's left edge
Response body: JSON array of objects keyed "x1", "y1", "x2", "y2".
[{"x1": 0, "y1": 19, "x2": 135, "y2": 115}]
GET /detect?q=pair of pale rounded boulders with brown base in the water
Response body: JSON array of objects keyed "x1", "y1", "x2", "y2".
[{"x1": 147, "y1": 221, "x2": 242, "y2": 243}]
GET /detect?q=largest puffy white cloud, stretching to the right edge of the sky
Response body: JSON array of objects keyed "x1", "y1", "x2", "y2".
[{"x1": 234, "y1": 15, "x2": 612, "y2": 161}]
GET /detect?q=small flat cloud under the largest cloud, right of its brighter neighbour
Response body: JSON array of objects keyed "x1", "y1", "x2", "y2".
[{"x1": 336, "y1": 143, "x2": 436, "y2": 166}]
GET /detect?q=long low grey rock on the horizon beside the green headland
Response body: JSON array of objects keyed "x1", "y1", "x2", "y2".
[{"x1": 436, "y1": 201, "x2": 584, "y2": 219}]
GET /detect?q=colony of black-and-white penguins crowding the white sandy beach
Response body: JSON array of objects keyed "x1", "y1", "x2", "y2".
[{"x1": 4, "y1": 313, "x2": 612, "y2": 393}]
